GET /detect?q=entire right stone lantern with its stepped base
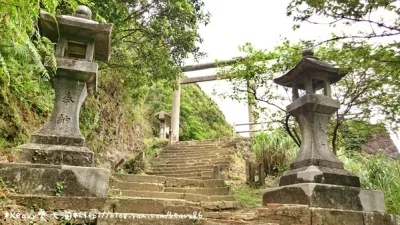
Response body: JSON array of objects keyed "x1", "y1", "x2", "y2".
[{"x1": 263, "y1": 49, "x2": 385, "y2": 212}]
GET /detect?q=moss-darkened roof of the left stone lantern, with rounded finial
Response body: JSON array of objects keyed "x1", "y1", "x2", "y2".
[{"x1": 40, "y1": 6, "x2": 113, "y2": 61}]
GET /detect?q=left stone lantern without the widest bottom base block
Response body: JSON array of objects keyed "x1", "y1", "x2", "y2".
[{"x1": 20, "y1": 6, "x2": 112, "y2": 166}]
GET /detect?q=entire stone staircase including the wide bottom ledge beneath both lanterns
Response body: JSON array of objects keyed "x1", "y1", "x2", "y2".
[{"x1": 0, "y1": 142, "x2": 400, "y2": 225}]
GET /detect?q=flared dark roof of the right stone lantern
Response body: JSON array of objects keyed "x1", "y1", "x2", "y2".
[{"x1": 274, "y1": 49, "x2": 346, "y2": 91}]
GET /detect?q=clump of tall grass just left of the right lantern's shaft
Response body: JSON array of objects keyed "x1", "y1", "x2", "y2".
[{"x1": 252, "y1": 130, "x2": 298, "y2": 175}]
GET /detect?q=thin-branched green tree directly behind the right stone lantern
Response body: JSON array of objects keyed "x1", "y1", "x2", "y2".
[{"x1": 220, "y1": 40, "x2": 400, "y2": 153}]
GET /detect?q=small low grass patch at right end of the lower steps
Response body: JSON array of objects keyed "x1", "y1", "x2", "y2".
[{"x1": 231, "y1": 185, "x2": 262, "y2": 207}]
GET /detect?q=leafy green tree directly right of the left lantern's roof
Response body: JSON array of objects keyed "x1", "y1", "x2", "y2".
[{"x1": 92, "y1": 0, "x2": 209, "y2": 87}]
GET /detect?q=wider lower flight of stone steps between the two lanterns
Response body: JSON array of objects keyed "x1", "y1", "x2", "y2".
[{"x1": 110, "y1": 174, "x2": 239, "y2": 208}]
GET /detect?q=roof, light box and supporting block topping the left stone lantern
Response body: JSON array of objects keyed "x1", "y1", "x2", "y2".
[{"x1": 40, "y1": 6, "x2": 112, "y2": 92}]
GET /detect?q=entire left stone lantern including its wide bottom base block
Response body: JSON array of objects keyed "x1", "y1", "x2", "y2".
[{"x1": 0, "y1": 6, "x2": 112, "y2": 197}]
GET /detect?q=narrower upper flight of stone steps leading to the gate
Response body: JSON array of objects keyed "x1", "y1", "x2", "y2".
[{"x1": 147, "y1": 141, "x2": 235, "y2": 180}]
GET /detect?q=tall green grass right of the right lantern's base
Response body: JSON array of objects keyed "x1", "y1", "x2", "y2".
[{"x1": 340, "y1": 152, "x2": 400, "y2": 214}]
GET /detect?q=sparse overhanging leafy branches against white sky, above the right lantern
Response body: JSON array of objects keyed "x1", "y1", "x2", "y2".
[{"x1": 286, "y1": 0, "x2": 400, "y2": 42}]
